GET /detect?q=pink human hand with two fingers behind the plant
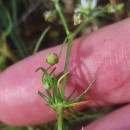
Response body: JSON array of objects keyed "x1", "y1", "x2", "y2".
[{"x1": 0, "y1": 19, "x2": 130, "y2": 130}]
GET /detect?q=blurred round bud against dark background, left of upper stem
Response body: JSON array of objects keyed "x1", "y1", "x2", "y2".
[{"x1": 44, "y1": 10, "x2": 56, "y2": 22}]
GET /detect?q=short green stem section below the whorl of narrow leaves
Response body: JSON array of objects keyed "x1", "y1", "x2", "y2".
[{"x1": 57, "y1": 106, "x2": 62, "y2": 130}]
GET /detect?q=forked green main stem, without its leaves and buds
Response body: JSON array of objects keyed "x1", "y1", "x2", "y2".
[{"x1": 54, "y1": 1, "x2": 105, "y2": 130}]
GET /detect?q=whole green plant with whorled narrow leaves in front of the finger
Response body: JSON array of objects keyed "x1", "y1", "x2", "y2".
[{"x1": 36, "y1": 0, "x2": 122, "y2": 130}]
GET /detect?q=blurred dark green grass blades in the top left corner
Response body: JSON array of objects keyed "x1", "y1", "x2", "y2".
[{"x1": 0, "y1": 0, "x2": 29, "y2": 57}]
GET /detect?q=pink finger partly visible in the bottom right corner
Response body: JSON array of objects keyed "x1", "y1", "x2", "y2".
[{"x1": 84, "y1": 105, "x2": 130, "y2": 130}]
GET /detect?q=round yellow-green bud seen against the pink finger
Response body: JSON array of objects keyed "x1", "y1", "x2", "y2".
[{"x1": 46, "y1": 53, "x2": 59, "y2": 65}]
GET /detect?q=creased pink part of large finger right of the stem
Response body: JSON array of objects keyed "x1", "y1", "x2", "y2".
[{"x1": 69, "y1": 19, "x2": 130, "y2": 106}]
